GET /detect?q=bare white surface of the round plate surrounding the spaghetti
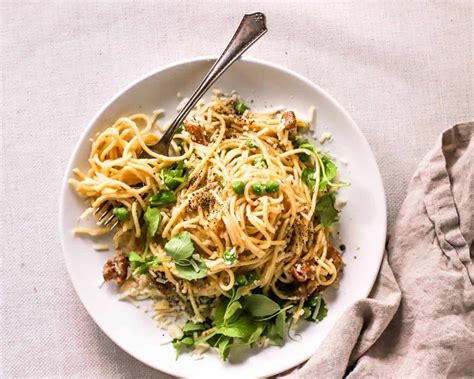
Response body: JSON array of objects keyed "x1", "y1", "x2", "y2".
[{"x1": 60, "y1": 58, "x2": 386, "y2": 378}]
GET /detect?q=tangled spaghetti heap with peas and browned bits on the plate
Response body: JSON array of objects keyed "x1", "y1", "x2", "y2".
[{"x1": 70, "y1": 95, "x2": 342, "y2": 360}]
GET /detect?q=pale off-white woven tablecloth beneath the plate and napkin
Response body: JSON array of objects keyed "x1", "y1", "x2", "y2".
[{"x1": 0, "y1": 0, "x2": 474, "y2": 378}]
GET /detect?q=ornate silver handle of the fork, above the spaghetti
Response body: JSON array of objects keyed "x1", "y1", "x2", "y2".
[{"x1": 155, "y1": 12, "x2": 267, "y2": 146}]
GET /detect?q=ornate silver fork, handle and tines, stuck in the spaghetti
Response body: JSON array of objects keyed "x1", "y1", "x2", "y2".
[{"x1": 94, "y1": 12, "x2": 267, "y2": 230}]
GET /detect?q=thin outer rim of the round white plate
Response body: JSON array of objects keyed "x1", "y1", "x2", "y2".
[{"x1": 58, "y1": 55, "x2": 387, "y2": 376}]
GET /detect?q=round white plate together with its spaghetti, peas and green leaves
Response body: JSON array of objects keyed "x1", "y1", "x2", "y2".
[{"x1": 60, "y1": 58, "x2": 386, "y2": 377}]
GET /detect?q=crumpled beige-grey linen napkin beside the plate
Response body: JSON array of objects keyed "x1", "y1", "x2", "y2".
[{"x1": 287, "y1": 122, "x2": 474, "y2": 378}]
